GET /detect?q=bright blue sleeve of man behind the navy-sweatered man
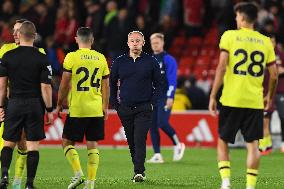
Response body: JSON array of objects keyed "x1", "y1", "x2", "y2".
[{"x1": 164, "y1": 55, "x2": 177, "y2": 98}]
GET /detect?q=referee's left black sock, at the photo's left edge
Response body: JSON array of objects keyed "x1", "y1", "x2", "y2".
[{"x1": 1, "y1": 146, "x2": 13, "y2": 178}]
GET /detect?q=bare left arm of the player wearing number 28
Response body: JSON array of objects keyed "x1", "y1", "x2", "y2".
[{"x1": 208, "y1": 50, "x2": 229, "y2": 115}]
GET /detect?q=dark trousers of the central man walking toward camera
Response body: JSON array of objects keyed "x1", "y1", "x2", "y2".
[{"x1": 117, "y1": 103, "x2": 153, "y2": 174}]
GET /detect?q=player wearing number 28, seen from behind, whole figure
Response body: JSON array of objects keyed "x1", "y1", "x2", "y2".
[{"x1": 209, "y1": 3, "x2": 277, "y2": 189}]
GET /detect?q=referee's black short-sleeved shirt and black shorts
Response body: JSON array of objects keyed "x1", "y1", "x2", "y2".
[{"x1": 0, "y1": 46, "x2": 51, "y2": 142}]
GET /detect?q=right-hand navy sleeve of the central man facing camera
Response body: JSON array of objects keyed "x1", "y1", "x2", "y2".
[{"x1": 151, "y1": 57, "x2": 163, "y2": 105}]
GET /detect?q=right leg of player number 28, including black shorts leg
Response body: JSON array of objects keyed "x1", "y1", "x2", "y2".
[{"x1": 241, "y1": 109, "x2": 264, "y2": 189}]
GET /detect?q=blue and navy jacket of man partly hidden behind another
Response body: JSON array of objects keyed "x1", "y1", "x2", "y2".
[{"x1": 153, "y1": 51, "x2": 177, "y2": 98}]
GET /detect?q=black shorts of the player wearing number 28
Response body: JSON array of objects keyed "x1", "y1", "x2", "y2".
[{"x1": 218, "y1": 106, "x2": 263, "y2": 143}]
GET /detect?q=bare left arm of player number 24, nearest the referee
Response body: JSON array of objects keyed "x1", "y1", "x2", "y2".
[{"x1": 56, "y1": 71, "x2": 72, "y2": 112}]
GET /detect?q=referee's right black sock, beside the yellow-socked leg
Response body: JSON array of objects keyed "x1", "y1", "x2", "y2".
[{"x1": 27, "y1": 151, "x2": 39, "y2": 186}]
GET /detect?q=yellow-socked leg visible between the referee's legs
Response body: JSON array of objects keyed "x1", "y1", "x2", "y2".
[{"x1": 12, "y1": 132, "x2": 27, "y2": 189}]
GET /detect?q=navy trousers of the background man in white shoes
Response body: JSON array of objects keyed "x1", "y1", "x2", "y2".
[{"x1": 150, "y1": 99, "x2": 176, "y2": 153}]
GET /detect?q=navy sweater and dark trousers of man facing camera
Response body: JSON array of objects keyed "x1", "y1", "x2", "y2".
[{"x1": 110, "y1": 52, "x2": 162, "y2": 177}]
